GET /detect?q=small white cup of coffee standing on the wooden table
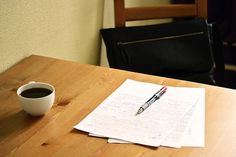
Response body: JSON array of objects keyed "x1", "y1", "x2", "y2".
[{"x1": 17, "y1": 81, "x2": 55, "y2": 116}]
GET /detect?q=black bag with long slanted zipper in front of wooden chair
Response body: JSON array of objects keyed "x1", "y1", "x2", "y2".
[{"x1": 101, "y1": 19, "x2": 214, "y2": 84}]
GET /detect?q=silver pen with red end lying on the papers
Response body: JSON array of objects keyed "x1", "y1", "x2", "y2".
[{"x1": 136, "y1": 86, "x2": 167, "y2": 115}]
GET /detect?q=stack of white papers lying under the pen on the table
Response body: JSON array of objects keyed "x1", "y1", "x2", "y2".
[{"x1": 75, "y1": 80, "x2": 205, "y2": 148}]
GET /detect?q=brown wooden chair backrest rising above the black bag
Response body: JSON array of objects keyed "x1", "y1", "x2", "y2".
[{"x1": 114, "y1": 0, "x2": 207, "y2": 27}]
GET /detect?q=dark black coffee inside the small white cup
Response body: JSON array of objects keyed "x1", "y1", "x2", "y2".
[{"x1": 20, "y1": 88, "x2": 52, "y2": 98}]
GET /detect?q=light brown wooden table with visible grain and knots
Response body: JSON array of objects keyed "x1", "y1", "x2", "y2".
[{"x1": 0, "y1": 55, "x2": 236, "y2": 157}]
